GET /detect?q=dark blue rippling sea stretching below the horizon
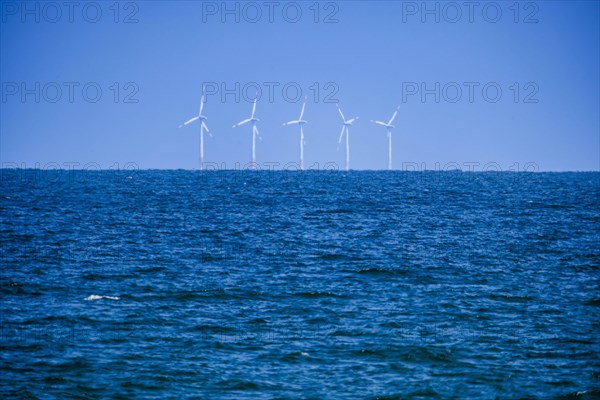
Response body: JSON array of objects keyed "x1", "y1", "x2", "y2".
[{"x1": 0, "y1": 170, "x2": 600, "y2": 399}]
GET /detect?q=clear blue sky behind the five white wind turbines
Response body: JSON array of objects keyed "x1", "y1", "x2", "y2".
[{"x1": 0, "y1": 1, "x2": 600, "y2": 171}]
